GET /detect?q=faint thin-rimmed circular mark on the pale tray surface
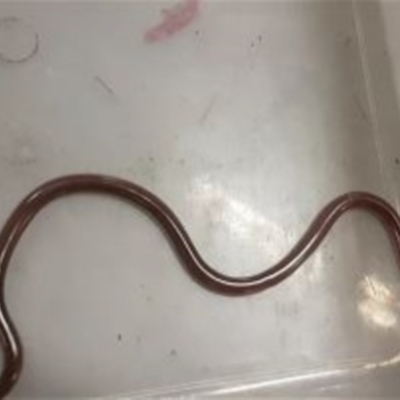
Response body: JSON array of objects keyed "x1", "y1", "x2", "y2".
[{"x1": 0, "y1": 16, "x2": 39, "y2": 64}]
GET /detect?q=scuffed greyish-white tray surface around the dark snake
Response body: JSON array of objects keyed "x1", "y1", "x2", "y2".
[{"x1": 0, "y1": 1, "x2": 400, "y2": 397}]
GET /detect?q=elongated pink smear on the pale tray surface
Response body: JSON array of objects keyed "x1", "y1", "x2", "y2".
[{"x1": 144, "y1": 0, "x2": 199, "y2": 43}]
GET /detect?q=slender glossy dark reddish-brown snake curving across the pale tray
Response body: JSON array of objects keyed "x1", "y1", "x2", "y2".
[{"x1": 0, "y1": 174, "x2": 400, "y2": 397}]
